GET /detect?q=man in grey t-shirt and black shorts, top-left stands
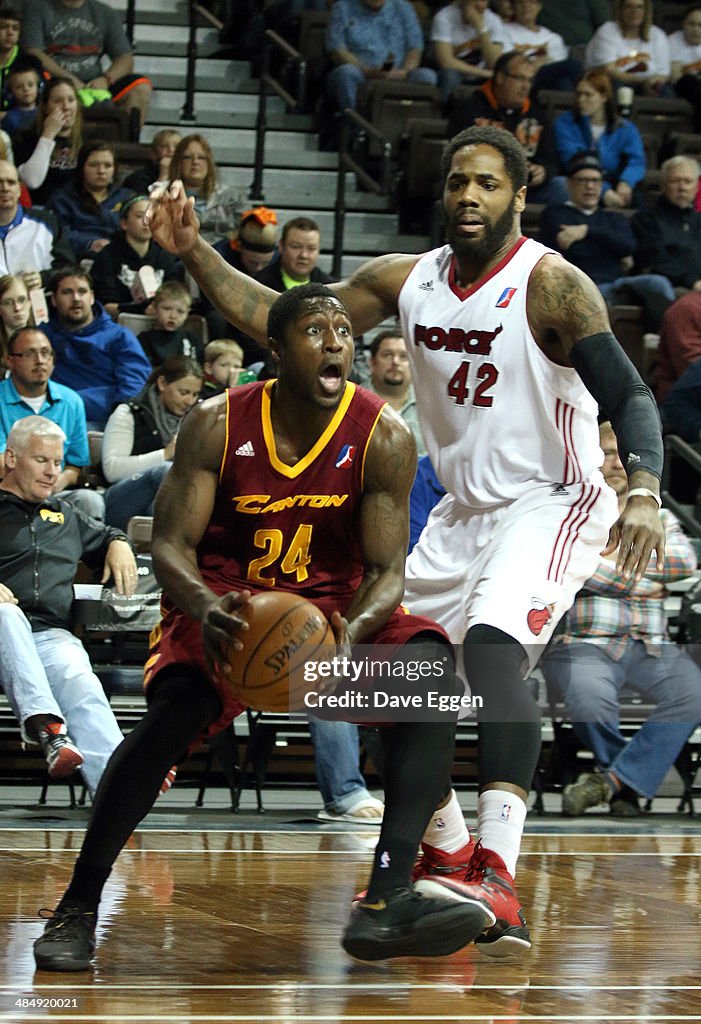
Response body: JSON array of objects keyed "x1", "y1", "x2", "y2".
[{"x1": 21, "y1": 0, "x2": 151, "y2": 130}]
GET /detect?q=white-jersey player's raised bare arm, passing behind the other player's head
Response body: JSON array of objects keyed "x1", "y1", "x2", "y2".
[{"x1": 146, "y1": 181, "x2": 419, "y2": 344}]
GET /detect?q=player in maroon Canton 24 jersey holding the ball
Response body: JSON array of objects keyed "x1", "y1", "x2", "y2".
[{"x1": 34, "y1": 284, "x2": 495, "y2": 971}]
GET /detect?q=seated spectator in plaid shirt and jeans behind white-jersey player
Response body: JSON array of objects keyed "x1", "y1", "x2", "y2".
[{"x1": 540, "y1": 424, "x2": 701, "y2": 816}]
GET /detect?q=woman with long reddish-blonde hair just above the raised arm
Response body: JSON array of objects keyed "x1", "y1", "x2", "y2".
[{"x1": 170, "y1": 133, "x2": 244, "y2": 242}]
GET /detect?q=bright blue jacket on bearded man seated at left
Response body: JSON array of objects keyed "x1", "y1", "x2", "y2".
[{"x1": 42, "y1": 302, "x2": 151, "y2": 424}]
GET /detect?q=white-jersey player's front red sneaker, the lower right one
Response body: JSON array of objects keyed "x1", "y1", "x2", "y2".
[{"x1": 417, "y1": 843, "x2": 531, "y2": 958}]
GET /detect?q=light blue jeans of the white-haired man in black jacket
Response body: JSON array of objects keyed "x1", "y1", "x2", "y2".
[{"x1": 0, "y1": 603, "x2": 122, "y2": 796}]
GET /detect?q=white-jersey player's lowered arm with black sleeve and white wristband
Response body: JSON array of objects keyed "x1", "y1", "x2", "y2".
[{"x1": 528, "y1": 256, "x2": 664, "y2": 580}]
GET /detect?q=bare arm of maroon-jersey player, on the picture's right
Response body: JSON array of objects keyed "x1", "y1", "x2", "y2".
[{"x1": 337, "y1": 406, "x2": 417, "y2": 643}]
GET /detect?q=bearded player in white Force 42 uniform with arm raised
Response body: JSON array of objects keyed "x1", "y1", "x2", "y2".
[{"x1": 145, "y1": 127, "x2": 664, "y2": 956}]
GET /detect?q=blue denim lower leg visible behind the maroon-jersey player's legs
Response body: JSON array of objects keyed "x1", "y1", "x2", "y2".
[{"x1": 309, "y1": 717, "x2": 370, "y2": 814}]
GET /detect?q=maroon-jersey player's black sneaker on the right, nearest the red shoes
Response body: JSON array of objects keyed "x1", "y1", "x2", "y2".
[{"x1": 343, "y1": 889, "x2": 496, "y2": 961}]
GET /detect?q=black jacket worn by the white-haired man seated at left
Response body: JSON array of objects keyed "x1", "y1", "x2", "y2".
[{"x1": 0, "y1": 489, "x2": 127, "y2": 631}]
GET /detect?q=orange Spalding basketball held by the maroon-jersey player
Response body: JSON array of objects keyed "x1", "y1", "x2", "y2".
[{"x1": 223, "y1": 590, "x2": 336, "y2": 713}]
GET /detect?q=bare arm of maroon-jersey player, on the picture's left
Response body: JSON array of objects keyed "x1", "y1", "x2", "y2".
[{"x1": 151, "y1": 395, "x2": 251, "y2": 663}]
